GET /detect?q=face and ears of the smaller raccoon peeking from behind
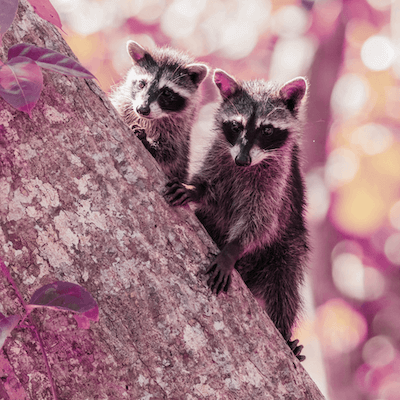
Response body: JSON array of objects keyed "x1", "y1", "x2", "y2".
[{"x1": 127, "y1": 41, "x2": 208, "y2": 119}]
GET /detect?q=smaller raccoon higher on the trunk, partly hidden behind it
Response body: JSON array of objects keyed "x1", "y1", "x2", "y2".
[{"x1": 110, "y1": 41, "x2": 208, "y2": 179}]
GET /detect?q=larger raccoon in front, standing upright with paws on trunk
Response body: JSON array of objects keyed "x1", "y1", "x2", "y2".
[{"x1": 165, "y1": 70, "x2": 309, "y2": 361}]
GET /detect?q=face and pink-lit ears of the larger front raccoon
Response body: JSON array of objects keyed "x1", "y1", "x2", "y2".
[{"x1": 214, "y1": 70, "x2": 307, "y2": 167}]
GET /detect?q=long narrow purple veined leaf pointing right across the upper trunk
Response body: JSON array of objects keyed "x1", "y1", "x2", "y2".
[{"x1": 8, "y1": 43, "x2": 96, "y2": 79}]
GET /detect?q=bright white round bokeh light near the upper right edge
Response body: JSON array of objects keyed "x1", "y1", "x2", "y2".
[{"x1": 361, "y1": 35, "x2": 396, "y2": 71}]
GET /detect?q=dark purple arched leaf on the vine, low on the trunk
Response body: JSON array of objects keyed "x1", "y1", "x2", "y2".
[{"x1": 27, "y1": 281, "x2": 98, "y2": 320}]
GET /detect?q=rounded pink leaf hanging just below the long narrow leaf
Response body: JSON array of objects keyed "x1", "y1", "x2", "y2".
[{"x1": 0, "y1": 56, "x2": 43, "y2": 116}]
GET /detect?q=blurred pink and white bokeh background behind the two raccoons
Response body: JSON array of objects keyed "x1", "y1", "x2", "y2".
[{"x1": 52, "y1": 0, "x2": 400, "y2": 400}]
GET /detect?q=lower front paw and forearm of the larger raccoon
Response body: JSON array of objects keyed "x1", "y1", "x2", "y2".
[{"x1": 206, "y1": 239, "x2": 243, "y2": 296}]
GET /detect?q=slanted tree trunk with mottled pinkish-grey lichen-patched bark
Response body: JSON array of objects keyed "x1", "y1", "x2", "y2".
[{"x1": 0, "y1": 0, "x2": 322, "y2": 400}]
